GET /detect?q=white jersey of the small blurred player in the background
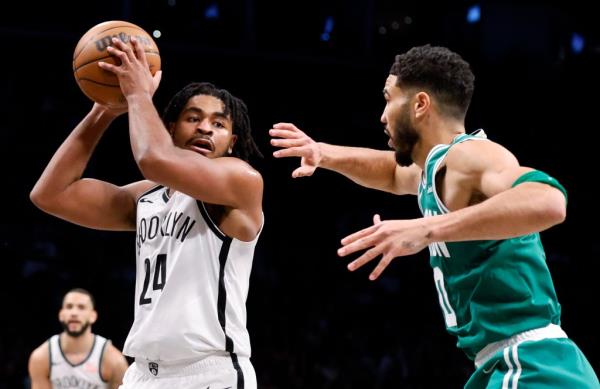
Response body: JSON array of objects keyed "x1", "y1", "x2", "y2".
[{"x1": 48, "y1": 335, "x2": 109, "y2": 389}]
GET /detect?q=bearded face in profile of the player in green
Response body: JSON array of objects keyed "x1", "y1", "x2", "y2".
[{"x1": 381, "y1": 75, "x2": 419, "y2": 166}]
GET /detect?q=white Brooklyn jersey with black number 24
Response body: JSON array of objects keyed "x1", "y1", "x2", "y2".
[{"x1": 124, "y1": 186, "x2": 258, "y2": 361}]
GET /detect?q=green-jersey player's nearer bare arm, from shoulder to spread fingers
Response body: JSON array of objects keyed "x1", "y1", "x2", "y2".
[{"x1": 338, "y1": 142, "x2": 566, "y2": 280}]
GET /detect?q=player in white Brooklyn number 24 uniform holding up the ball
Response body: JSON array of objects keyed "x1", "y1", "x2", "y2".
[{"x1": 31, "y1": 34, "x2": 263, "y2": 389}]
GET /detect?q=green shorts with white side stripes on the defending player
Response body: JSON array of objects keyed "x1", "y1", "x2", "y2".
[{"x1": 465, "y1": 338, "x2": 600, "y2": 389}]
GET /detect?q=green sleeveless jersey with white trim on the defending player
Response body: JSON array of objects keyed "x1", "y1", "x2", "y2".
[{"x1": 418, "y1": 132, "x2": 560, "y2": 359}]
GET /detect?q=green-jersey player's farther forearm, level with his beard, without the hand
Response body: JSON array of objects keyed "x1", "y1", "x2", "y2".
[{"x1": 319, "y1": 143, "x2": 404, "y2": 192}]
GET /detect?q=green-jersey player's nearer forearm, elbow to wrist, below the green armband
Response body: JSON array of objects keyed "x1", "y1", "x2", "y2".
[{"x1": 427, "y1": 183, "x2": 566, "y2": 242}]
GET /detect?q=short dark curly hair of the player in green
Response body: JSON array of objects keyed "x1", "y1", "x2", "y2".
[{"x1": 390, "y1": 45, "x2": 475, "y2": 119}]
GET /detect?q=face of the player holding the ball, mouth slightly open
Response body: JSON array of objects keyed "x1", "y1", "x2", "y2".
[{"x1": 169, "y1": 95, "x2": 236, "y2": 158}]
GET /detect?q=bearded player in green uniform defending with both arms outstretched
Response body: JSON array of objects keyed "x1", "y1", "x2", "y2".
[{"x1": 270, "y1": 45, "x2": 600, "y2": 389}]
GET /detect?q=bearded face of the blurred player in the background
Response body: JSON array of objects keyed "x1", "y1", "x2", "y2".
[{"x1": 58, "y1": 292, "x2": 97, "y2": 337}]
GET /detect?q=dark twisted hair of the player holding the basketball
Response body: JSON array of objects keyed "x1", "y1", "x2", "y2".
[{"x1": 162, "y1": 82, "x2": 262, "y2": 162}]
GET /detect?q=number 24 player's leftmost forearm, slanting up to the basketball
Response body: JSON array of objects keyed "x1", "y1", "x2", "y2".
[{"x1": 30, "y1": 105, "x2": 115, "y2": 206}]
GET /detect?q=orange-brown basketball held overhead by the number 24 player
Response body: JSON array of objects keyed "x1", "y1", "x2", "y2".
[{"x1": 73, "y1": 20, "x2": 160, "y2": 107}]
